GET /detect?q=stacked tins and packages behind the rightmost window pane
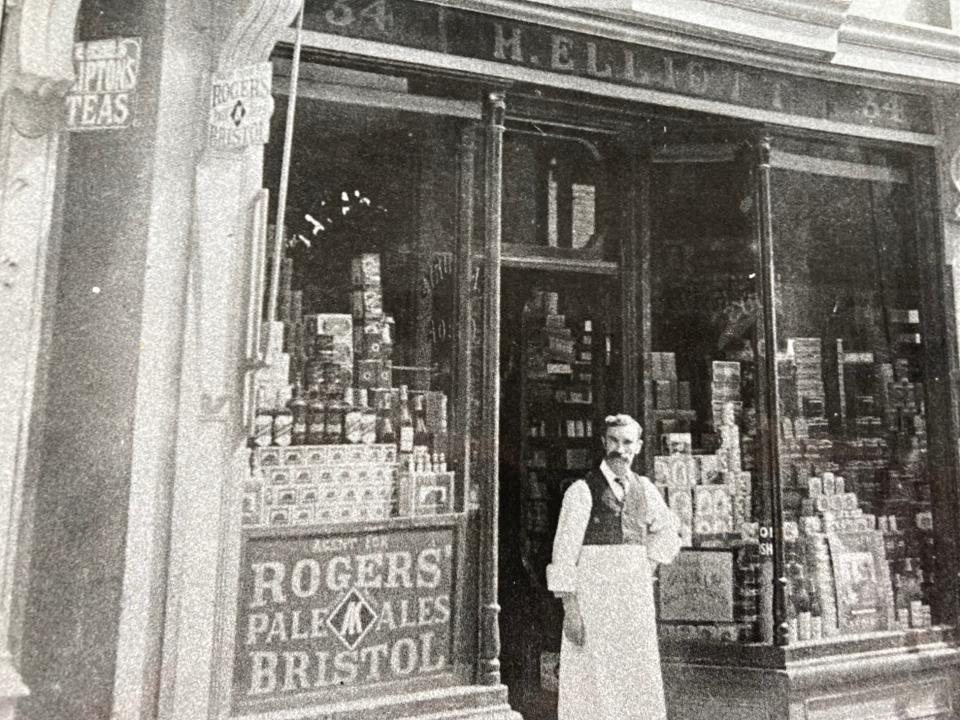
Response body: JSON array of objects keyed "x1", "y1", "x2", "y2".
[{"x1": 778, "y1": 326, "x2": 933, "y2": 640}]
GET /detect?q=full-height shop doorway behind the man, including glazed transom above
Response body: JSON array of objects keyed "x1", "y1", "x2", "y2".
[{"x1": 499, "y1": 115, "x2": 635, "y2": 720}]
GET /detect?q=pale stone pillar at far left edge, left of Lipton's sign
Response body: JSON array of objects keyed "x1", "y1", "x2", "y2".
[{"x1": 0, "y1": 0, "x2": 80, "y2": 720}]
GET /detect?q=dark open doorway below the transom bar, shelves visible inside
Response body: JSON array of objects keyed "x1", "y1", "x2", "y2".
[{"x1": 500, "y1": 268, "x2": 621, "y2": 720}]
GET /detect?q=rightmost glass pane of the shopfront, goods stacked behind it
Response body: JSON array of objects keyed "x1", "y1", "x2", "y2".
[{"x1": 771, "y1": 141, "x2": 935, "y2": 642}]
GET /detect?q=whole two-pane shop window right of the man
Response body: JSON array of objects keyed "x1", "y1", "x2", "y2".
[{"x1": 645, "y1": 132, "x2": 952, "y2": 647}]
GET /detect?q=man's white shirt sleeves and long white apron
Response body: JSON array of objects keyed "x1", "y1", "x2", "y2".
[{"x1": 547, "y1": 475, "x2": 680, "y2": 720}]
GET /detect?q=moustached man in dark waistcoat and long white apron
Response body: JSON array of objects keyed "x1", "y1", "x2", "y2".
[{"x1": 547, "y1": 415, "x2": 680, "y2": 720}]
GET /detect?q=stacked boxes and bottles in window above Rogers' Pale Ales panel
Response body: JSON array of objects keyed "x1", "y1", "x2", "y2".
[{"x1": 243, "y1": 254, "x2": 454, "y2": 526}]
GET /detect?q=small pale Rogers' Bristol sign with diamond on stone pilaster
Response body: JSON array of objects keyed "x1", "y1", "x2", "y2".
[{"x1": 207, "y1": 62, "x2": 273, "y2": 150}]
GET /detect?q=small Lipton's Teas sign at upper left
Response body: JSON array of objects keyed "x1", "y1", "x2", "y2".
[{"x1": 64, "y1": 37, "x2": 141, "y2": 132}]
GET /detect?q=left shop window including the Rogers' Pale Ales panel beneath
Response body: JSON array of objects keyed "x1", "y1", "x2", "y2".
[{"x1": 233, "y1": 78, "x2": 481, "y2": 711}]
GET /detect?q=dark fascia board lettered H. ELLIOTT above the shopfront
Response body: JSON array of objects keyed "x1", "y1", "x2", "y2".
[{"x1": 304, "y1": 0, "x2": 933, "y2": 133}]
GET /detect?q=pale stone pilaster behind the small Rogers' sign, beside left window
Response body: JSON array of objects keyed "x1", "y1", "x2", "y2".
[{"x1": 158, "y1": 5, "x2": 300, "y2": 720}]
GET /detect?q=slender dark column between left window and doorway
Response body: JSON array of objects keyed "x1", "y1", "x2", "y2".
[{"x1": 479, "y1": 91, "x2": 506, "y2": 685}]
